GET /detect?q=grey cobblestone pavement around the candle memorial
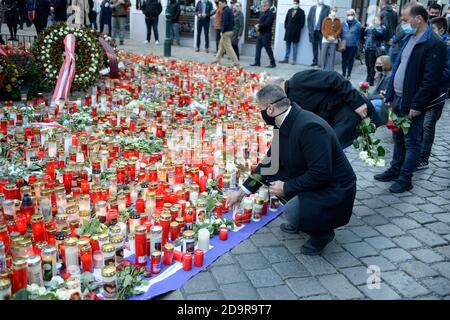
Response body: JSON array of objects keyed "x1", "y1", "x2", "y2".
[{"x1": 7, "y1": 26, "x2": 450, "y2": 300}]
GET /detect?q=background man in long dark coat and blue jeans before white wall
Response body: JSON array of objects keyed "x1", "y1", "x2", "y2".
[{"x1": 280, "y1": 0, "x2": 305, "y2": 64}]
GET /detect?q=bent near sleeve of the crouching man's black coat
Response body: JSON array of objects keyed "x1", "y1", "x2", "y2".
[{"x1": 283, "y1": 123, "x2": 333, "y2": 198}]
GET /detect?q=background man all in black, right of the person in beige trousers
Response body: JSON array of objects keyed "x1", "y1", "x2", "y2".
[{"x1": 251, "y1": 0, "x2": 277, "y2": 68}]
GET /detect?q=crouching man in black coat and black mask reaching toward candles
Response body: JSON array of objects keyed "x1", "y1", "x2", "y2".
[{"x1": 228, "y1": 85, "x2": 356, "y2": 255}]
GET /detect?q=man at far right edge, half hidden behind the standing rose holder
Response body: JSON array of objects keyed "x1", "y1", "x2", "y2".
[{"x1": 417, "y1": 17, "x2": 450, "y2": 170}]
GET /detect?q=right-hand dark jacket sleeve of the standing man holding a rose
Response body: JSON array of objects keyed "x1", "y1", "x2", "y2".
[{"x1": 411, "y1": 41, "x2": 447, "y2": 111}]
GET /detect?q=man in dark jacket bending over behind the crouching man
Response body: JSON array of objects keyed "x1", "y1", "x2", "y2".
[{"x1": 268, "y1": 69, "x2": 383, "y2": 148}]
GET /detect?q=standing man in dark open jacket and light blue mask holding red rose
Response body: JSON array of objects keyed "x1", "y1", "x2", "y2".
[{"x1": 374, "y1": 3, "x2": 446, "y2": 193}]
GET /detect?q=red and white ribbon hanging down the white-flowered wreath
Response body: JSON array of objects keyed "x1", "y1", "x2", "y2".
[{"x1": 52, "y1": 34, "x2": 75, "y2": 105}]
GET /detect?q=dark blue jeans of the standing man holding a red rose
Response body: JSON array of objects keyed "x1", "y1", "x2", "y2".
[{"x1": 389, "y1": 95, "x2": 424, "y2": 182}]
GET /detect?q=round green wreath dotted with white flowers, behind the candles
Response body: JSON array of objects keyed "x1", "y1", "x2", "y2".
[{"x1": 31, "y1": 22, "x2": 105, "y2": 91}]
